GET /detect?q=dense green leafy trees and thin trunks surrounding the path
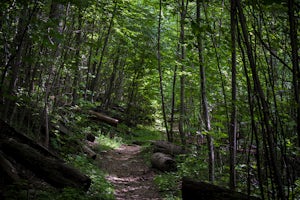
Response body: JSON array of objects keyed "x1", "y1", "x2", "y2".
[{"x1": 0, "y1": 0, "x2": 300, "y2": 199}]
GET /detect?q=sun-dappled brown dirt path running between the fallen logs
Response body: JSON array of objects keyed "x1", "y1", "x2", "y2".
[{"x1": 100, "y1": 145, "x2": 162, "y2": 200}]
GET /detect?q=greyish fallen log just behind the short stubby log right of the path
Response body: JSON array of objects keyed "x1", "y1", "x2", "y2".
[{"x1": 152, "y1": 140, "x2": 185, "y2": 156}]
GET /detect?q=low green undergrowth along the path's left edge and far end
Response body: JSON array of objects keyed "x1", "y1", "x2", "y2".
[{"x1": 44, "y1": 104, "x2": 165, "y2": 200}]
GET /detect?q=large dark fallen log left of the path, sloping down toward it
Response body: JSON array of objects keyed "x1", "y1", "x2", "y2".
[{"x1": 0, "y1": 138, "x2": 91, "y2": 191}]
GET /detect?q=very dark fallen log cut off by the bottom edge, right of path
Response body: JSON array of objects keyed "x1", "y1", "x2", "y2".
[{"x1": 181, "y1": 178, "x2": 259, "y2": 200}]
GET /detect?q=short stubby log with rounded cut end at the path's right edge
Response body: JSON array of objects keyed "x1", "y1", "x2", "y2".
[{"x1": 151, "y1": 152, "x2": 176, "y2": 171}]
